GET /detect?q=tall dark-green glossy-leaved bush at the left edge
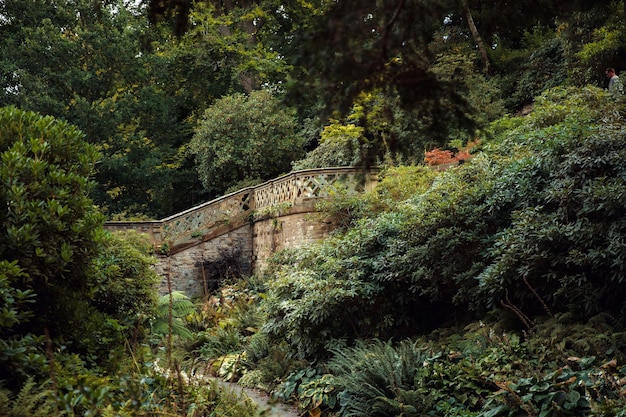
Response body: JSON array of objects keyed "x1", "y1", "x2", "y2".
[{"x1": 0, "y1": 107, "x2": 103, "y2": 384}]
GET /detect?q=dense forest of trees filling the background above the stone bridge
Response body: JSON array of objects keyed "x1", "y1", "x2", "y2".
[{"x1": 0, "y1": 0, "x2": 626, "y2": 218}]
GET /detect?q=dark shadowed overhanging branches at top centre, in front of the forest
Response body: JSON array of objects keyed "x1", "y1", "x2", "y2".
[{"x1": 290, "y1": 1, "x2": 476, "y2": 132}]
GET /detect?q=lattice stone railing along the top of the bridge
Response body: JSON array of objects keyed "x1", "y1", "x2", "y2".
[{"x1": 105, "y1": 167, "x2": 376, "y2": 249}]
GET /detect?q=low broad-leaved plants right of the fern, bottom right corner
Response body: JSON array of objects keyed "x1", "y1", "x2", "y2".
[{"x1": 432, "y1": 315, "x2": 622, "y2": 417}]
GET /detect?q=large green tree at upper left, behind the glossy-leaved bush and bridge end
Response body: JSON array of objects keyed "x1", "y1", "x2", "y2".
[{"x1": 0, "y1": 0, "x2": 205, "y2": 217}]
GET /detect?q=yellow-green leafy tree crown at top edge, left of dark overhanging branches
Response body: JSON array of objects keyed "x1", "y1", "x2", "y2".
[{"x1": 148, "y1": 0, "x2": 302, "y2": 93}]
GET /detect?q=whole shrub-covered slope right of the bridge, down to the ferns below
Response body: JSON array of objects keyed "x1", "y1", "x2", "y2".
[{"x1": 195, "y1": 87, "x2": 626, "y2": 417}]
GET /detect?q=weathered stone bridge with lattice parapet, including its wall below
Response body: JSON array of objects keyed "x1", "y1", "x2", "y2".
[{"x1": 105, "y1": 167, "x2": 377, "y2": 296}]
